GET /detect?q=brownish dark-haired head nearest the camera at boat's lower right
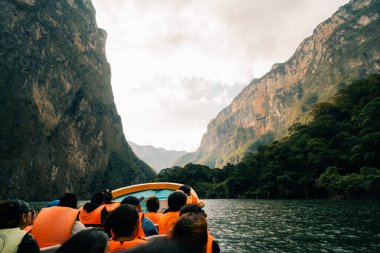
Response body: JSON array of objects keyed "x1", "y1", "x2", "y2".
[{"x1": 172, "y1": 213, "x2": 208, "y2": 252}]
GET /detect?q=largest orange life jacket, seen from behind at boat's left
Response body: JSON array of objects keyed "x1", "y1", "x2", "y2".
[{"x1": 32, "y1": 206, "x2": 78, "y2": 248}]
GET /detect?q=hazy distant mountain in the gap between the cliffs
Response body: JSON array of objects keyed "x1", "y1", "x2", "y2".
[{"x1": 128, "y1": 141, "x2": 187, "y2": 172}]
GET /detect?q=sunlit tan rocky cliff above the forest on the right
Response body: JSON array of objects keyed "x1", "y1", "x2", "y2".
[{"x1": 176, "y1": 0, "x2": 380, "y2": 167}]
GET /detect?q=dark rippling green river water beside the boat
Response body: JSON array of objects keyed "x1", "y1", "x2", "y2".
[{"x1": 31, "y1": 199, "x2": 380, "y2": 253}]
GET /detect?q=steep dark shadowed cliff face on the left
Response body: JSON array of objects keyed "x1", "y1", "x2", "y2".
[{"x1": 0, "y1": 0, "x2": 154, "y2": 200}]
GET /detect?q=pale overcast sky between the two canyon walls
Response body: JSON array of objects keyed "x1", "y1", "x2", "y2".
[{"x1": 92, "y1": 0, "x2": 348, "y2": 151}]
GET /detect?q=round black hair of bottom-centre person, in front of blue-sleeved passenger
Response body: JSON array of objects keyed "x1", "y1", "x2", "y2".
[{"x1": 104, "y1": 204, "x2": 139, "y2": 237}]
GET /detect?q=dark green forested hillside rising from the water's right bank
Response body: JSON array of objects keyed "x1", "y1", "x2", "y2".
[{"x1": 155, "y1": 74, "x2": 380, "y2": 199}]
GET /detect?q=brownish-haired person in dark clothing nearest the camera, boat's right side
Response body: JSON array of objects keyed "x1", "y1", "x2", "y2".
[{"x1": 125, "y1": 213, "x2": 208, "y2": 253}]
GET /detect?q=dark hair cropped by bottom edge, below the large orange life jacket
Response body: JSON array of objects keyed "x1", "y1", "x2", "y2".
[{"x1": 56, "y1": 229, "x2": 108, "y2": 253}]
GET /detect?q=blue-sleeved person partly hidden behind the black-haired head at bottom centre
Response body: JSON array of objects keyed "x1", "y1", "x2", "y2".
[{"x1": 120, "y1": 196, "x2": 158, "y2": 238}]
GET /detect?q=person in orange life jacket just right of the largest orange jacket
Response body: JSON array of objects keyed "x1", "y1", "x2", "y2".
[{"x1": 79, "y1": 192, "x2": 108, "y2": 227}]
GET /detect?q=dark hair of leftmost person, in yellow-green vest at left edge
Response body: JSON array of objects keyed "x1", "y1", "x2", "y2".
[{"x1": 0, "y1": 200, "x2": 22, "y2": 229}]
